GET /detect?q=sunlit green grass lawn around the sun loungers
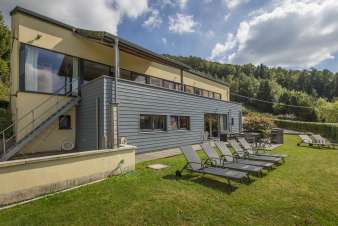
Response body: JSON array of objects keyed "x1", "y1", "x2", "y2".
[{"x1": 0, "y1": 136, "x2": 338, "y2": 225}]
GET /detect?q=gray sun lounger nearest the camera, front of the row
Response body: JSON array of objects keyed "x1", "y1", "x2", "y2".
[{"x1": 176, "y1": 146, "x2": 250, "y2": 184}]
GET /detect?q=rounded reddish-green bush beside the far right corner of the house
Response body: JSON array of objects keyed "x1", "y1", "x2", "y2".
[{"x1": 243, "y1": 112, "x2": 274, "y2": 138}]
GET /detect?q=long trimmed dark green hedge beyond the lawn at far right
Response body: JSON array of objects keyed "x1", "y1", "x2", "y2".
[{"x1": 274, "y1": 119, "x2": 338, "y2": 141}]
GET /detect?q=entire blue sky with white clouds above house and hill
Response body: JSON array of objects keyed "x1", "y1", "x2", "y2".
[{"x1": 0, "y1": 0, "x2": 338, "y2": 72}]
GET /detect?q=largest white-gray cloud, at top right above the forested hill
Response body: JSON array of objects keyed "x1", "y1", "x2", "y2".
[{"x1": 211, "y1": 0, "x2": 338, "y2": 68}]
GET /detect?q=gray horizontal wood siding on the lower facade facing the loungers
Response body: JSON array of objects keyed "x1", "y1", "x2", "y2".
[{"x1": 104, "y1": 78, "x2": 241, "y2": 152}]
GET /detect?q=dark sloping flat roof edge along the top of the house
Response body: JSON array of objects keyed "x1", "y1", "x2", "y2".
[{"x1": 10, "y1": 6, "x2": 228, "y2": 86}]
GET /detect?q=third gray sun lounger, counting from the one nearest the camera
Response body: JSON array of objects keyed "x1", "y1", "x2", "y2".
[{"x1": 215, "y1": 142, "x2": 274, "y2": 169}]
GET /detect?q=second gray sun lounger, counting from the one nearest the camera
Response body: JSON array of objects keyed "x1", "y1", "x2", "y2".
[{"x1": 201, "y1": 143, "x2": 263, "y2": 176}]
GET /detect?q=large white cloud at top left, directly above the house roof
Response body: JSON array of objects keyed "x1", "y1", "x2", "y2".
[{"x1": 0, "y1": 0, "x2": 148, "y2": 34}]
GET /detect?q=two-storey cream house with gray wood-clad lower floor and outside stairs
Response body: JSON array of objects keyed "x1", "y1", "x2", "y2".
[{"x1": 1, "y1": 7, "x2": 241, "y2": 160}]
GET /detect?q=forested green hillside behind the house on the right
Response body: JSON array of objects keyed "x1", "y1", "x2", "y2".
[{"x1": 165, "y1": 55, "x2": 338, "y2": 122}]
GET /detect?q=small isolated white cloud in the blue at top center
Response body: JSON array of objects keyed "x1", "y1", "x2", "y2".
[{"x1": 169, "y1": 13, "x2": 199, "y2": 34}]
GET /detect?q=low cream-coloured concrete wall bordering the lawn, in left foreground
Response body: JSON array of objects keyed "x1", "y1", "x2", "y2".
[{"x1": 0, "y1": 146, "x2": 135, "y2": 206}]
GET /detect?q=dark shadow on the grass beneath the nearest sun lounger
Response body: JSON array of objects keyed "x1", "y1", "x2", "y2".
[{"x1": 163, "y1": 174, "x2": 238, "y2": 195}]
